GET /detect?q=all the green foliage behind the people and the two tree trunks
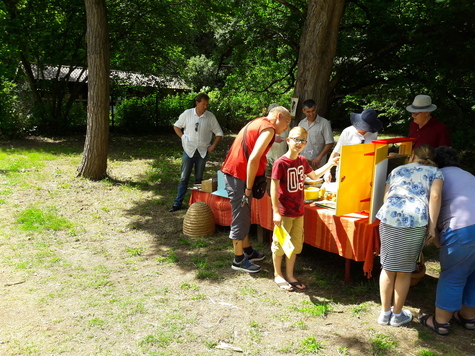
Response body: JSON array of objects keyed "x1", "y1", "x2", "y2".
[{"x1": 0, "y1": 0, "x2": 475, "y2": 150}]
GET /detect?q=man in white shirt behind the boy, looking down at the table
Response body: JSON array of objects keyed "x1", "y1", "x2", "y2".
[{"x1": 298, "y1": 99, "x2": 335, "y2": 169}]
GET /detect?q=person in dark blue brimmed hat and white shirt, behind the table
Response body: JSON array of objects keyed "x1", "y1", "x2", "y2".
[{"x1": 324, "y1": 109, "x2": 383, "y2": 182}]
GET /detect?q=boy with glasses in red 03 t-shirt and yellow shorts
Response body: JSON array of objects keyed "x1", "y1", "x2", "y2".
[{"x1": 271, "y1": 126, "x2": 339, "y2": 292}]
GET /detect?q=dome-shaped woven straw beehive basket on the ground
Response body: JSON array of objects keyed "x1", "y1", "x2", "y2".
[{"x1": 183, "y1": 202, "x2": 216, "y2": 237}]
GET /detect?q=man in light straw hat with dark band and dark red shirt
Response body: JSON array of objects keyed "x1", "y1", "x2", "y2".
[{"x1": 406, "y1": 95, "x2": 451, "y2": 148}]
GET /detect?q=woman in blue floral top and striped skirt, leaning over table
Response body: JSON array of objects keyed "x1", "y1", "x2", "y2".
[{"x1": 376, "y1": 145, "x2": 444, "y2": 326}]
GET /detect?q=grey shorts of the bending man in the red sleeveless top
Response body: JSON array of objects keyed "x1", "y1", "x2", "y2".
[{"x1": 224, "y1": 174, "x2": 252, "y2": 241}]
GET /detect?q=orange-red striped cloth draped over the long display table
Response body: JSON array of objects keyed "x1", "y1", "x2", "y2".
[{"x1": 190, "y1": 190, "x2": 380, "y2": 277}]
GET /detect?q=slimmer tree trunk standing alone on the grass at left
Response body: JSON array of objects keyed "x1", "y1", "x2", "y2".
[{"x1": 77, "y1": 0, "x2": 110, "y2": 180}]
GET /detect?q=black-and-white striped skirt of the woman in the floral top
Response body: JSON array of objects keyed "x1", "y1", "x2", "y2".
[{"x1": 379, "y1": 223, "x2": 427, "y2": 272}]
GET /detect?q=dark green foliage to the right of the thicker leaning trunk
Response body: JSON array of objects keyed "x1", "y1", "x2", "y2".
[{"x1": 330, "y1": 0, "x2": 475, "y2": 150}]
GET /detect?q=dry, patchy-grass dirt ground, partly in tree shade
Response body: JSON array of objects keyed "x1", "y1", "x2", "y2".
[{"x1": 0, "y1": 137, "x2": 475, "y2": 355}]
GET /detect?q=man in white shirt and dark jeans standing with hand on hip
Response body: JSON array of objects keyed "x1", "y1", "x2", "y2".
[{"x1": 168, "y1": 93, "x2": 223, "y2": 212}]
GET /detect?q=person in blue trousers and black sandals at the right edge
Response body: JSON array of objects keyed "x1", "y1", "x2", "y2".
[{"x1": 419, "y1": 146, "x2": 475, "y2": 335}]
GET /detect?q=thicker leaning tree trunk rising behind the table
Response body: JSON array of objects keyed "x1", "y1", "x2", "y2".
[{"x1": 295, "y1": 0, "x2": 345, "y2": 122}]
